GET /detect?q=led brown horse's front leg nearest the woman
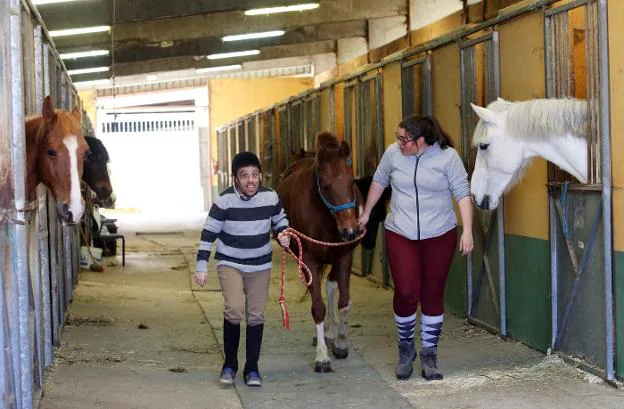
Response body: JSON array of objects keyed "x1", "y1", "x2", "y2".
[{"x1": 332, "y1": 253, "x2": 353, "y2": 359}]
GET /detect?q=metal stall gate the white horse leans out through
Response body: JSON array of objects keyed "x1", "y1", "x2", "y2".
[{"x1": 545, "y1": 0, "x2": 615, "y2": 379}]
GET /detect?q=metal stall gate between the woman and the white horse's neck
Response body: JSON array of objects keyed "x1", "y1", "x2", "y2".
[{"x1": 460, "y1": 31, "x2": 507, "y2": 336}]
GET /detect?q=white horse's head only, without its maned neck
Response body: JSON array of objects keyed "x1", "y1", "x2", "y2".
[{"x1": 470, "y1": 98, "x2": 530, "y2": 210}]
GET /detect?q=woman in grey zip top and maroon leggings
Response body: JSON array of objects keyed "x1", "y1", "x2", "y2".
[{"x1": 359, "y1": 116, "x2": 474, "y2": 380}]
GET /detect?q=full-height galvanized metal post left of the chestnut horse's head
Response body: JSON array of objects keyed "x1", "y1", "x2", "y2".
[{"x1": 9, "y1": 0, "x2": 33, "y2": 408}]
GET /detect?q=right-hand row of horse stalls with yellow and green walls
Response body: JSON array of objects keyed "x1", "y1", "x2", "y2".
[{"x1": 218, "y1": 0, "x2": 624, "y2": 381}]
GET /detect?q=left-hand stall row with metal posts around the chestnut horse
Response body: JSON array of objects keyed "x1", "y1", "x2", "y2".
[{"x1": 0, "y1": 0, "x2": 79, "y2": 409}]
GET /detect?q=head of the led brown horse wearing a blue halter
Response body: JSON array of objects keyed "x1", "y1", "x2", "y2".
[{"x1": 315, "y1": 132, "x2": 360, "y2": 241}]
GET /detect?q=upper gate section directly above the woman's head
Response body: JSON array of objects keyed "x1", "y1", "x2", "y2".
[{"x1": 401, "y1": 54, "x2": 433, "y2": 118}]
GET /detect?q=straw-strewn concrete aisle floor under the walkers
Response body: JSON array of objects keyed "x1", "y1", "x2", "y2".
[{"x1": 39, "y1": 214, "x2": 624, "y2": 409}]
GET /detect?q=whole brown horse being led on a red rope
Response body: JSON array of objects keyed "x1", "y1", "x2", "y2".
[{"x1": 277, "y1": 132, "x2": 363, "y2": 372}]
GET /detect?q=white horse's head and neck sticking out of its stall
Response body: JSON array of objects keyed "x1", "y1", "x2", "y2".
[{"x1": 470, "y1": 98, "x2": 588, "y2": 210}]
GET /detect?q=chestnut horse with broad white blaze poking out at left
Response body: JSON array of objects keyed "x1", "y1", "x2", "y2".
[{"x1": 26, "y1": 96, "x2": 88, "y2": 223}]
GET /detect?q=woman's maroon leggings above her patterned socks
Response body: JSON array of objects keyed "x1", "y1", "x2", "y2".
[{"x1": 386, "y1": 228, "x2": 457, "y2": 317}]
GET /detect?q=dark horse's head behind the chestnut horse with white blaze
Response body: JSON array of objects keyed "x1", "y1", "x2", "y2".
[{"x1": 82, "y1": 136, "x2": 116, "y2": 208}]
